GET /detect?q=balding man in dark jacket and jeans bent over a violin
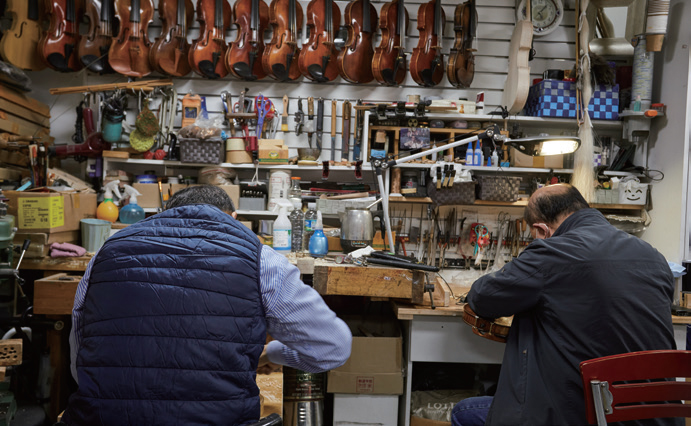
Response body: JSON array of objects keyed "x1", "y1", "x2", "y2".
[{"x1": 452, "y1": 185, "x2": 681, "y2": 426}]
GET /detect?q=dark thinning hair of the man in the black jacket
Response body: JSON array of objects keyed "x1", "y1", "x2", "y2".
[{"x1": 524, "y1": 184, "x2": 590, "y2": 226}]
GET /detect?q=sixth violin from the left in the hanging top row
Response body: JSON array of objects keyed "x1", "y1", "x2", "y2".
[{"x1": 189, "y1": 0, "x2": 233, "y2": 79}]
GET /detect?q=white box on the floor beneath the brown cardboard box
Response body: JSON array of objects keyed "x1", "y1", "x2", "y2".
[{"x1": 333, "y1": 393, "x2": 400, "y2": 426}]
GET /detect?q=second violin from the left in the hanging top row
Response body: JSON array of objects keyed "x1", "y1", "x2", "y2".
[{"x1": 38, "y1": 0, "x2": 84, "y2": 72}]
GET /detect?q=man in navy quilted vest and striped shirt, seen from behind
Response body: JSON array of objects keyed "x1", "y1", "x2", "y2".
[{"x1": 62, "y1": 185, "x2": 352, "y2": 426}]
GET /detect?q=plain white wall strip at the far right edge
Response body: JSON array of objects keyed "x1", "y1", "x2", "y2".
[{"x1": 642, "y1": 0, "x2": 691, "y2": 262}]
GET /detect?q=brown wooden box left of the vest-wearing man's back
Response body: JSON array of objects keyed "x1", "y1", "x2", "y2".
[{"x1": 34, "y1": 273, "x2": 82, "y2": 315}]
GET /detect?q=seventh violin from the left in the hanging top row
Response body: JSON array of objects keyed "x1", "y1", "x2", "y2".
[{"x1": 226, "y1": 0, "x2": 269, "y2": 81}]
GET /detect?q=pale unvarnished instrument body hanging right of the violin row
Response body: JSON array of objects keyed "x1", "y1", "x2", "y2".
[{"x1": 501, "y1": 2, "x2": 533, "y2": 114}]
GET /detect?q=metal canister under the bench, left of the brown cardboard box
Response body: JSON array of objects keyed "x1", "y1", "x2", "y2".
[{"x1": 283, "y1": 367, "x2": 326, "y2": 426}]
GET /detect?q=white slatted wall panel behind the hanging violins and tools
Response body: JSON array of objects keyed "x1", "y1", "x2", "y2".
[{"x1": 24, "y1": 0, "x2": 575, "y2": 161}]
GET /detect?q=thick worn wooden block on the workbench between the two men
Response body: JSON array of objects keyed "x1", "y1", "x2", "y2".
[{"x1": 313, "y1": 264, "x2": 421, "y2": 300}]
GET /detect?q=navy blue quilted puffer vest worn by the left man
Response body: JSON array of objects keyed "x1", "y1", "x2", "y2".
[{"x1": 63, "y1": 205, "x2": 266, "y2": 426}]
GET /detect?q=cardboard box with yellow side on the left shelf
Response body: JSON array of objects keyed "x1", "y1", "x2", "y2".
[{"x1": 4, "y1": 188, "x2": 96, "y2": 234}]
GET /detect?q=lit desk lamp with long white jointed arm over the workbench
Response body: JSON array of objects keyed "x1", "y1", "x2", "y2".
[{"x1": 372, "y1": 125, "x2": 581, "y2": 250}]
